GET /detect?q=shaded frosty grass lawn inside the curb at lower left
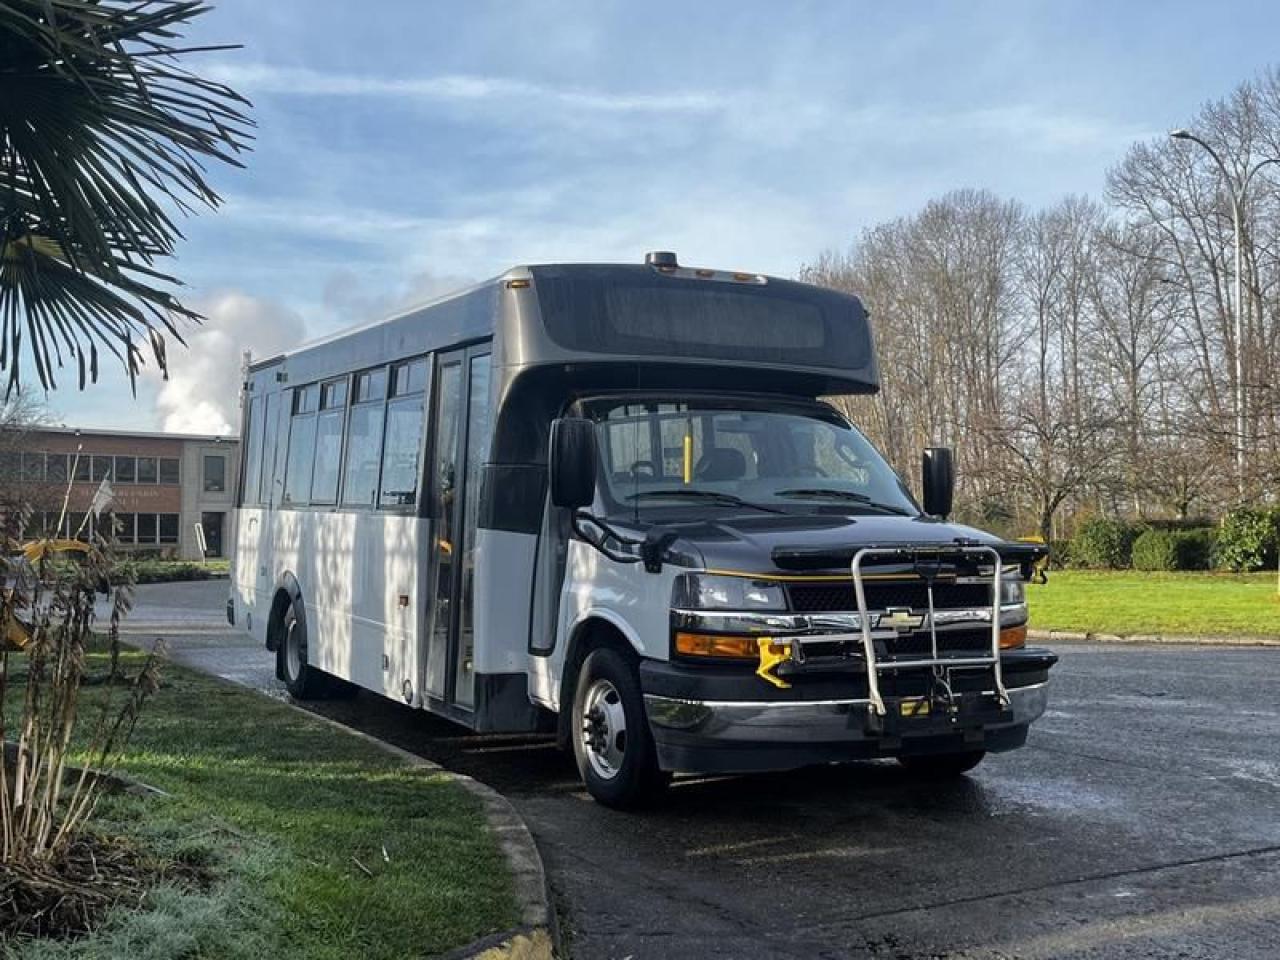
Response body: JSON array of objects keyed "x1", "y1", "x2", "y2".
[{"x1": 8, "y1": 654, "x2": 518, "y2": 960}]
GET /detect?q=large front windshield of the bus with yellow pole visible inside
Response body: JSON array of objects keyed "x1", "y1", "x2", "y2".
[{"x1": 589, "y1": 398, "x2": 920, "y2": 517}]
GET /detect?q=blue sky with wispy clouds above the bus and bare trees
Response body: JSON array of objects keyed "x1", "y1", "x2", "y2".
[{"x1": 32, "y1": 0, "x2": 1280, "y2": 433}]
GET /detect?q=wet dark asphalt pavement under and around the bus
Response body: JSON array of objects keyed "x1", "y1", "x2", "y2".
[{"x1": 115, "y1": 582, "x2": 1280, "y2": 960}]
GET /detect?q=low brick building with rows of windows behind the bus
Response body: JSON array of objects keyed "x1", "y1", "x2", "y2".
[{"x1": 0, "y1": 428, "x2": 239, "y2": 559}]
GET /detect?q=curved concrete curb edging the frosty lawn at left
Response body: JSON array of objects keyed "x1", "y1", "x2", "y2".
[{"x1": 122, "y1": 635, "x2": 562, "y2": 960}]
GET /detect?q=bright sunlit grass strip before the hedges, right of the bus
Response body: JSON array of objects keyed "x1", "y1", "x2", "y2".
[{"x1": 1027, "y1": 570, "x2": 1280, "y2": 636}]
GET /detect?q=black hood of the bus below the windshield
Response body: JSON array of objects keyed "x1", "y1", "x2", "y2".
[{"x1": 611, "y1": 513, "x2": 1046, "y2": 573}]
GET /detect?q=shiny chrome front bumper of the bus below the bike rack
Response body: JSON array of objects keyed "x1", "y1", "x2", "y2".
[{"x1": 644, "y1": 682, "x2": 1048, "y2": 746}]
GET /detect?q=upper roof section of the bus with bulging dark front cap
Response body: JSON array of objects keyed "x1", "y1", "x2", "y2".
[{"x1": 250, "y1": 255, "x2": 878, "y2": 393}]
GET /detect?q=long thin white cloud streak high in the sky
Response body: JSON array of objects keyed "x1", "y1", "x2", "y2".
[{"x1": 204, "y1": 63, "x2": 724, "y2": 113}]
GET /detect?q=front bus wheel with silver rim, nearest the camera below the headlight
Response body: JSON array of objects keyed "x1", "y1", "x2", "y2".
[{"x1": 570, "y1": 649, "x2": 671, "y2": 809}]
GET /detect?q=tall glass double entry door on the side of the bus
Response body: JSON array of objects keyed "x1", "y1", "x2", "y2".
[{"x1": 424, "y1": 346, "x2": 493, "y2": 710}]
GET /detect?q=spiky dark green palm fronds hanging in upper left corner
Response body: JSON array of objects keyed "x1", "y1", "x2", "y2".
[{"x1": 0, "y1": 0, "x2": 252, "y2": 393}]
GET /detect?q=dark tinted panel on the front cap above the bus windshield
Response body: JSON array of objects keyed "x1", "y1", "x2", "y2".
[{"x1": 534, "y1": 268, "x2": 870, "y2": 369}]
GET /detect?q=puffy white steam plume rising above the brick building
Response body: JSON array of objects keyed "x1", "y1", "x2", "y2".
[{"x1": 145, "y1": 291, "x2": 305, "y2": 434}]
